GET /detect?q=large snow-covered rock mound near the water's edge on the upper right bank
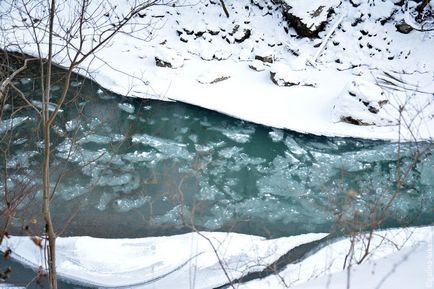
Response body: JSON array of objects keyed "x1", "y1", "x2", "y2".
[{"x1": 332, "y1": 80, "x2": 399, "y2": 126}]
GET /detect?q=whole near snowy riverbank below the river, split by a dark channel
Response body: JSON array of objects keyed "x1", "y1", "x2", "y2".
[{"x1": 1, "y1": 227, "x2": 434, "y2": 289}]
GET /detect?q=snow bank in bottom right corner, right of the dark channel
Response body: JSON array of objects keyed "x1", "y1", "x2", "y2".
[{"x1": 239, "y1": 226, "x2": 434, "y2": 289}]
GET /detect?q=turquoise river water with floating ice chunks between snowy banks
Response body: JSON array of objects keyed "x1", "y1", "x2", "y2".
[{"x1": 0, "y1": 67, "x2": 434, "y2": 288}]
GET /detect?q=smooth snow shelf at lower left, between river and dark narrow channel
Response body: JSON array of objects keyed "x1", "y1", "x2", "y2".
[{"x1": 1, "y1": 232, "x2": 327, "y2": 288}]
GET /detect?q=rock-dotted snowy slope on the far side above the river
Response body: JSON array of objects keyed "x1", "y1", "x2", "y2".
[{"x1": 0, "y1": 0, "x2": 434, "y2": 140}]
